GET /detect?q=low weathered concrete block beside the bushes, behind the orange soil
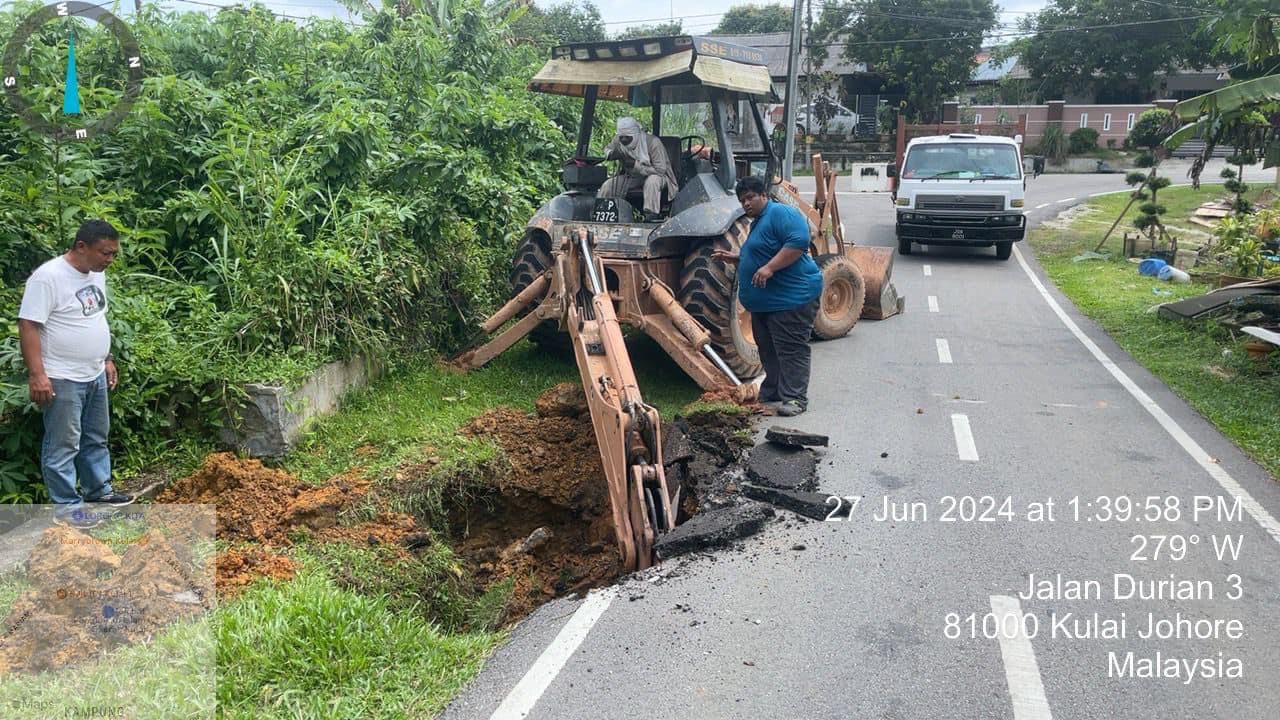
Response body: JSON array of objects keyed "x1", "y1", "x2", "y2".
[{"x1": 221, "y1": 357, "x2": 381, "y2": 457}]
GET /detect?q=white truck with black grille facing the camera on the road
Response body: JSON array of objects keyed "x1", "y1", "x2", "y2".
[{"x1": 888, "y1": 133, "x2": 1027, "y2": 260}]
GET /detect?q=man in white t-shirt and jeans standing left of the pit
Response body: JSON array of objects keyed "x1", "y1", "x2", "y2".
[{"x1": 18, "y1": 215, "x2": 133, "y2": 528}]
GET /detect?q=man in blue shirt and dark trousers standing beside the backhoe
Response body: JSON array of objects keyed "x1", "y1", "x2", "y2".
[{"x1": 714, "y1": 177, "x2": 822, "y2": 418}]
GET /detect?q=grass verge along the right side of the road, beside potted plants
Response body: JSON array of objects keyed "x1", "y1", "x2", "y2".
[{"x1": 1030, "y1": 184, "x2": 1280, "y2": 477}]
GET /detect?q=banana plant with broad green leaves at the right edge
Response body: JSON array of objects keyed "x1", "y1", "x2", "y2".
[{"x1": 1164, "y1": 74, "x2": 1280, "y2": 183}]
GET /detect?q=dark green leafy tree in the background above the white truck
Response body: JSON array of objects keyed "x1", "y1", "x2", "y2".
[{"x1": 813, "y1": 0, "x2": 996, "y2": 120}]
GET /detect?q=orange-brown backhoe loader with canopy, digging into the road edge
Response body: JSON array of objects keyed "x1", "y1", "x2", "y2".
[{"x1": 457, "y1": 36, "x2": 901, "y2": 569}]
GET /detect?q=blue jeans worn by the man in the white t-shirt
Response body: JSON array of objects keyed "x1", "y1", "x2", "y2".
[{"x1": 40, "y1": 373, "x2": 111, "y2": 505}]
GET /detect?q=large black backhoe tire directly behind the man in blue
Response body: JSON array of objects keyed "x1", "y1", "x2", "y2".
[{"x1": 678, "y1": 220, "x2": 762, "y2": 380}]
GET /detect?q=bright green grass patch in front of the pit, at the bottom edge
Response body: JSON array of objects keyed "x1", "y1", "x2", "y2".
[{"x1": 218, "y1": 569, "x2": 502, "y2": 720}]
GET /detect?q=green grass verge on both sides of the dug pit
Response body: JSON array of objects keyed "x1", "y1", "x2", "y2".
[{"x1": 204, "y1": 336, "x2": 701, "y2": 719}]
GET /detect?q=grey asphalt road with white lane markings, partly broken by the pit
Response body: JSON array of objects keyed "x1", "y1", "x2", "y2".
[{"x1": 444, "y1": 173, "x2": 1280, "y2": 720}]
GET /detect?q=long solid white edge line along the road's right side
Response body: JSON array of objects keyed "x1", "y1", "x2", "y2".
[{"x1": 1014, "y1": 245, "x2": 1280, "y2": 542}]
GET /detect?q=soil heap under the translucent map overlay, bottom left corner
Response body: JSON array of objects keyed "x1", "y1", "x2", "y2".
[{"x1": 0, "y1": 527, "x2": 214, "y2": 675}]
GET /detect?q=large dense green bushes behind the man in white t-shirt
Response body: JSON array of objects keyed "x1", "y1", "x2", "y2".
[{"x1": 0, "y1": 0, "x2": 581, "y2": 501}]
